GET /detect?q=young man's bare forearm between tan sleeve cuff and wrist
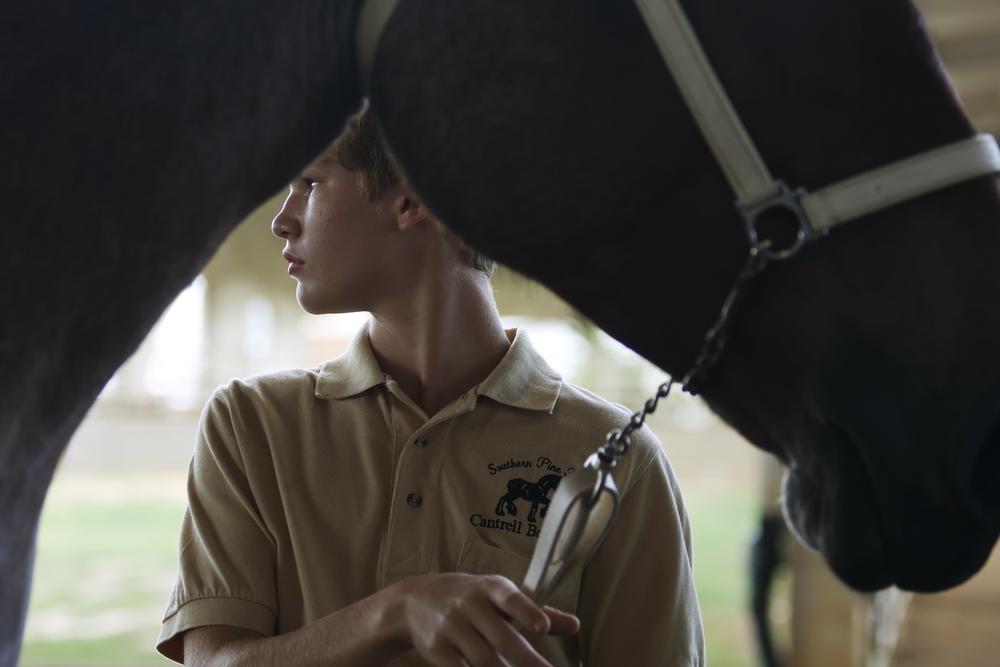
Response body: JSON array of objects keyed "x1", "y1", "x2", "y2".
[{"x1": 184, "y1": 587, "x2": 410, "y2": 667}]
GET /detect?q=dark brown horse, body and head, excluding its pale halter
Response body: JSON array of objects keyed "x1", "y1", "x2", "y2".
[{"x1": 0, "y1": 0, "x2": 1000, "y2": 667}]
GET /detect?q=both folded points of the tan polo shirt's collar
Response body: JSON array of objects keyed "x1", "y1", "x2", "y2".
[{"x1": 316, "y1": 324, "x2": 562, "y2": 413}]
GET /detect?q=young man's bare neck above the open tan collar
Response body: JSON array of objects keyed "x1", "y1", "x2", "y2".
[{"x1": 368, "y1": 270, "x2": 510, "y2": 416}]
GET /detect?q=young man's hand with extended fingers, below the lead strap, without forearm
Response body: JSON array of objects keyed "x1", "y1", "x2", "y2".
[{"x1": 397, "y1": 573, "x2": 580, "y2": 667}]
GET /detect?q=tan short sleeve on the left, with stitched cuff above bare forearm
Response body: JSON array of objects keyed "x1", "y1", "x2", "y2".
[{"x1": 156, "y1": 389, "x2": 277, "y2": 662}]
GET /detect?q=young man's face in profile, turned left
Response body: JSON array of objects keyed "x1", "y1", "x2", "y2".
[{"x1": 271, "y1": 158, "x2": 412, "y2": 313}]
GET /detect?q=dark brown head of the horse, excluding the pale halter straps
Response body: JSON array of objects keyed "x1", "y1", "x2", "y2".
[{"x1": 374, "y1": 0, "x2": 1000, "y2": 591}]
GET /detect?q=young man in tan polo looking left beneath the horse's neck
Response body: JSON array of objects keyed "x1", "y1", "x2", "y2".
[{"x1": 157, "y1": 107, "x2": 704, "y2": 667}]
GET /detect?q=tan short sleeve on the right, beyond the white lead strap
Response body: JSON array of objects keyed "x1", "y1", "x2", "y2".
[{"x1": 577, "y1": 438, "x2": 705, "y2": 667}]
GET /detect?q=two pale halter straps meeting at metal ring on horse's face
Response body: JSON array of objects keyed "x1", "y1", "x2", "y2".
[{"x1": 635, "y1": 0, "x2": 1000, "y2": 238}]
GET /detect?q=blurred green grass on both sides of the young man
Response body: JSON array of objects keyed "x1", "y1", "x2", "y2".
[{"x1": 21, "y1": 479, "x2": 758, "y2": 667}]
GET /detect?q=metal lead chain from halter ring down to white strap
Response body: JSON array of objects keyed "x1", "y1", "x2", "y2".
[{"x1": 594, "y1": 241, "x2": 771, "y2": 472}]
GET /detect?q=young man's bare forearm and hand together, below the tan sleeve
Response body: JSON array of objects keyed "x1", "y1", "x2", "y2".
[{"x1": 180, "y1": 574, "x2": 580, "y2": 667}]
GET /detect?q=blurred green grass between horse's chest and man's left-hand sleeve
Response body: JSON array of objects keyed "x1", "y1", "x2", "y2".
[{"x1": 21, "y1": 480, "x2": 184, "y2": 666}]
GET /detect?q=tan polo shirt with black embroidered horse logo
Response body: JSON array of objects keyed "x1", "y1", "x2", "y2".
[{"x1": 157, "y1": 326, "x2": 704, "y2": 667}]
